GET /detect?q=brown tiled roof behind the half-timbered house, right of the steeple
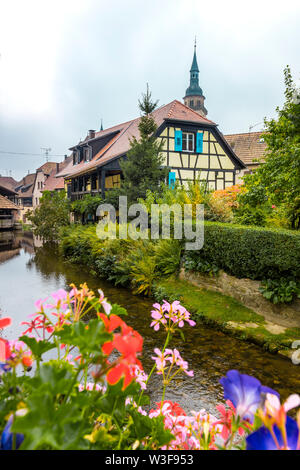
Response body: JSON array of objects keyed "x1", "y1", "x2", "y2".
[{"x1": 224, "y1": 131, "x2": 267, "y2": 165}]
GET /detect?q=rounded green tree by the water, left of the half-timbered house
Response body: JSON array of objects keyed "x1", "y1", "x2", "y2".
[{"x1": 27, "y1": 191, "x2": 70, "y2": 242}]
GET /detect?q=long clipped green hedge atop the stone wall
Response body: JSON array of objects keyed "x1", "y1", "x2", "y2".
[{"x1": 184, "y1": 222, "x2": 300, "y2": 280}]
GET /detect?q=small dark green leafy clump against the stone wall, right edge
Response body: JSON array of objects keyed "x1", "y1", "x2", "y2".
[{"x1": 259, "y1": 277, "x2": 300, "y2": 304}]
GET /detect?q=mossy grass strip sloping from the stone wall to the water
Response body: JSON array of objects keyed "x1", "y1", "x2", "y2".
[{"x1": 157, "y1": 277, "x2": 300, "y2": 359}]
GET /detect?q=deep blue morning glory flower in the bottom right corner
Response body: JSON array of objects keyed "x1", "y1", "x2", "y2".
[{"x1": 246, "y1": 416, "x2": 300, "y2": 450}]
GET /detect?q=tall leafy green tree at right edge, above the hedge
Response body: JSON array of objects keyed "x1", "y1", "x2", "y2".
[{"x1": 241, "y1": 66, "x2": 300, "y2": 229}]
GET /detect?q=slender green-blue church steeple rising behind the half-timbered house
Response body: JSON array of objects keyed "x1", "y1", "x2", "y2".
[{"x1": 183, "y1": 38, "x2": 207, "y2": 116}]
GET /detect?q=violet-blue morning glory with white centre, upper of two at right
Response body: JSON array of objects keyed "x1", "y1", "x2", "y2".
[{"x1": 220, "y1": 370, "x2": 279, "y2": 423}]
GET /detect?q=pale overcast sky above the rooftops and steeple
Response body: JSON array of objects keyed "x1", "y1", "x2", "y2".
[{"x1": 0, "y1": 0, "x2": 300, "y2": 179}]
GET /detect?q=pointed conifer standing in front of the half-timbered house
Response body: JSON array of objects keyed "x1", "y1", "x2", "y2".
[{"x1": 119, "y1": 84, "x2": 168, "y2": 202}]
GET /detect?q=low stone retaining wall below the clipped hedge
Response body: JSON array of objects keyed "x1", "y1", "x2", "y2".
[{"x1": 180, "y1": 269, "x2": 300, "y2": 327}]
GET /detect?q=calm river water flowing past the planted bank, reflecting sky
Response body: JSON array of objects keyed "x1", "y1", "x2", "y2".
[{"x1": 0, "y1": 234, "x2": 300, "y2": 411}]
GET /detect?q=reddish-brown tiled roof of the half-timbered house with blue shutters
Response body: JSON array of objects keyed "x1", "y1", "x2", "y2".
[{"x1": 62, "y1": 100, "x2": 215, "y2": 176}]
